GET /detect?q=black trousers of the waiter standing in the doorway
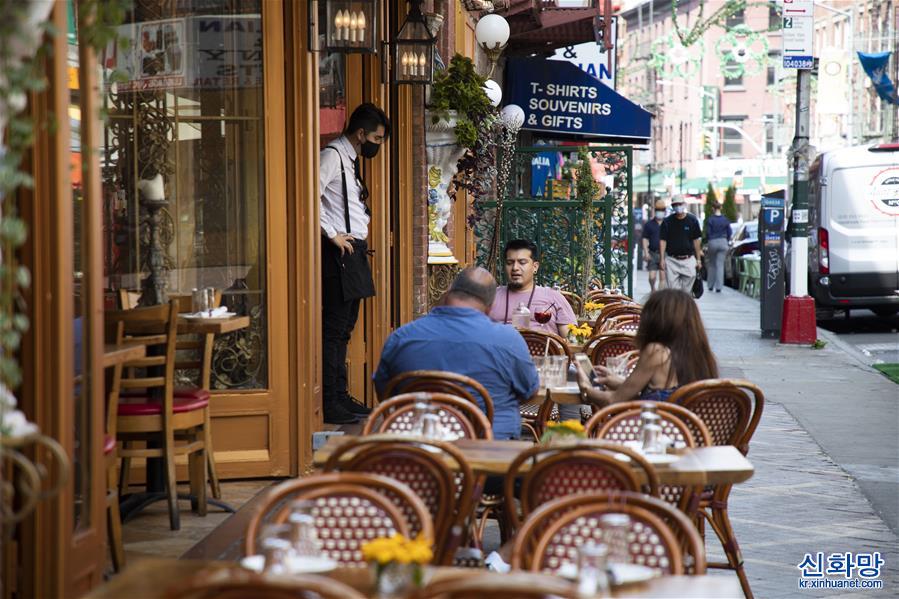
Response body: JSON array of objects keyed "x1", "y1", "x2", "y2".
[{"x1": 322, "y1": 276, "x2": 361, "y2": 408}]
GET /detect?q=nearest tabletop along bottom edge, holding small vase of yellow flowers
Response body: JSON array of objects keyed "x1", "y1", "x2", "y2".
[{"x1": 86, "y1": 558, "x2": 743, "y2": 599}]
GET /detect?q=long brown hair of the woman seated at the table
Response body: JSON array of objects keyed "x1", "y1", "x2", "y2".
[{"x1": 636, "y1": 289, "x2": 718, "y2": 385}]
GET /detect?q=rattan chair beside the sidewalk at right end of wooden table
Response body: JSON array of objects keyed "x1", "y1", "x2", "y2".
[{"x1": 668, "y1": 379, "x2": 765, "y2": 598}]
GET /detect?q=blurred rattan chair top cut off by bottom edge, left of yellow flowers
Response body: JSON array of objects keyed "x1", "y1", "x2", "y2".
[{"x1": 165, "y1": 566, "x2": 365, "y2": 599}]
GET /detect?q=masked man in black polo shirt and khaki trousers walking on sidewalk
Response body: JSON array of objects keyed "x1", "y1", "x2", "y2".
[{"x1": 659, "y1": 196, "x2": 702, "y2": 293}]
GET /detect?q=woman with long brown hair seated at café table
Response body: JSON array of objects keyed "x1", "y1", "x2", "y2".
[{"x1": 579, "y1": 289, "x2": 718, "y2": 405}]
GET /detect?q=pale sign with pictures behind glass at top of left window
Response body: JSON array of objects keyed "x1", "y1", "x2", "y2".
[{"x1": 110, "y1": 14, "x2": 262, "y2": 91}]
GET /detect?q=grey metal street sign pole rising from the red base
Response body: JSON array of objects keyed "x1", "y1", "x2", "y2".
[{"x1": 790, "y1": 69, "x2": 812, "y2": 297}]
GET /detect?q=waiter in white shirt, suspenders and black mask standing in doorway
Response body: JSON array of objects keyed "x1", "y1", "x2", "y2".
[{"x1": 319, "y1": 103, "x2": 390, "y2": 424}]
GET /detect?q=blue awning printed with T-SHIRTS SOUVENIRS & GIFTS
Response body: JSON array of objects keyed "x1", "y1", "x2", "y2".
[{"x1": 503, "y1": 57, "x2": 652, "y2": 143}]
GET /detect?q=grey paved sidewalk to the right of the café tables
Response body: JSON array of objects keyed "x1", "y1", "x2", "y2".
[{"x1": 634, "y1": 271, "x2": 899, "y2": 599}]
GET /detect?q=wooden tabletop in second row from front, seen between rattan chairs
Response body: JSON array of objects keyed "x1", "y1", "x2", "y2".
[{"x1": 313, "y1": 435, "x2": 755, "y2": 485}]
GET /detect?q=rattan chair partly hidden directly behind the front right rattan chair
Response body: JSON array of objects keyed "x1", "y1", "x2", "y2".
[{"x1": 504, "y1": 444, "x2": 659, "y2": 530}]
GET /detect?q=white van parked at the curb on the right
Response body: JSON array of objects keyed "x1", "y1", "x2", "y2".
[{"x1": 808, "y1": 144, "x2": 899, "y2": 315}]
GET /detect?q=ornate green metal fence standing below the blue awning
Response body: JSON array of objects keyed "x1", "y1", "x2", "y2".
[{"x1": 474, "y1": 146, "x2": 634, "y2": 295}]
